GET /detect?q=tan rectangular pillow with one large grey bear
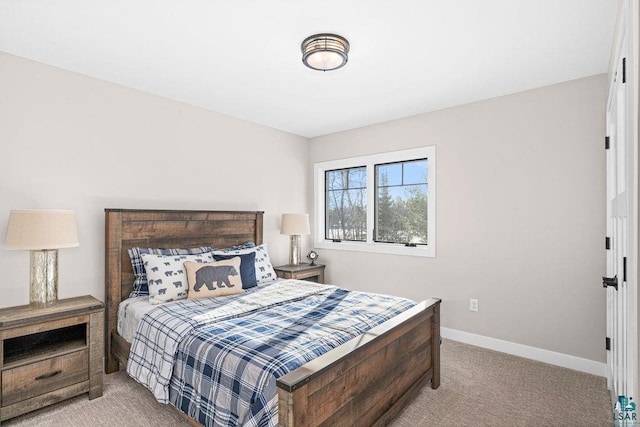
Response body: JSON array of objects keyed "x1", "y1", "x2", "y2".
[{"x1": 184, "y1": 256, "x2": 242, "y2": 299}]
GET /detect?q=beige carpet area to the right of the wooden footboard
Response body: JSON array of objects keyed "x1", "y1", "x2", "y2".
[{"x1": 393, "y1": 340, "x2": 613, "y2": 427}]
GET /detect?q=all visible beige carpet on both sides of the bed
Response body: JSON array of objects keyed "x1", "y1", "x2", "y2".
[{"x1": 2, "y1": 340, "x2": 612, "y2": 427}]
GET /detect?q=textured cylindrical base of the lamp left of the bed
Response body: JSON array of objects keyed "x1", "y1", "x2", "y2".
[{"x1": 29, "y1": 249, "x2": 58, "y2": 307}]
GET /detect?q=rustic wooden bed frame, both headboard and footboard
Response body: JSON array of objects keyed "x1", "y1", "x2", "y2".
[{"x1": 105, "y1": 209, "x2": 440, "y2": 427}]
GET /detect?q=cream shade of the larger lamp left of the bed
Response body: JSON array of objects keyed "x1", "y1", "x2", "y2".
[{"x1": 5, "y1": 209, "x2": 80, "y2": 250}]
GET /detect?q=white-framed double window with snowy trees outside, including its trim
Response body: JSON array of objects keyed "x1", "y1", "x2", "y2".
[{"x1": 314, "y1": 146, "x2": 435, "y2": 257}]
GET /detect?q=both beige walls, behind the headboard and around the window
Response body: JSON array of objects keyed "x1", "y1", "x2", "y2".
[{"x1": 0, "y1": 53, "x2": 606, "y2": 361}]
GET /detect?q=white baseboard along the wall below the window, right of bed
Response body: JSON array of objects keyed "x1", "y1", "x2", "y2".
[{"x1": 440, "y1": 328, "x2": 607, "y2": 377}]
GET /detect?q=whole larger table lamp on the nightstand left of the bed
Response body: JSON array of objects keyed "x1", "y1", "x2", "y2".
[{"x1": 5, "y1": 209, "x2": 79, "y2": 307}]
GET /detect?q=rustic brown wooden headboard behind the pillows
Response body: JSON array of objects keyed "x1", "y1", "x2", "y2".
[{"x1": 105, "y1": 209, "x2": 264, "y2": 372}]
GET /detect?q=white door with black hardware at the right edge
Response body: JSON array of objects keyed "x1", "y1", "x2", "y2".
[{"x1": 603, "y1": 17, "x2": 640, "y2": 413}]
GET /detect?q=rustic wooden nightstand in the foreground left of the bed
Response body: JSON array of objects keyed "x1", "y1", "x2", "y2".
[{"x1": 0, "y1": 296, "x2": 104, "y2": 422}]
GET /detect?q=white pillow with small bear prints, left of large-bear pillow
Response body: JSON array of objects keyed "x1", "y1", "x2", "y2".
[{"x1": 142, "y1": 252, "x2": 213, "y2": 304}]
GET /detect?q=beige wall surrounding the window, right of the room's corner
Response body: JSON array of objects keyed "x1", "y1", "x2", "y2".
[{"x1": 308, "y1": 75, "x2": 607, "y2": 362}]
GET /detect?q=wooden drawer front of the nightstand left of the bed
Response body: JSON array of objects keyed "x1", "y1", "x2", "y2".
[{"x1": 2, "y1": 349, "x2": 89, "y2": 406}]
